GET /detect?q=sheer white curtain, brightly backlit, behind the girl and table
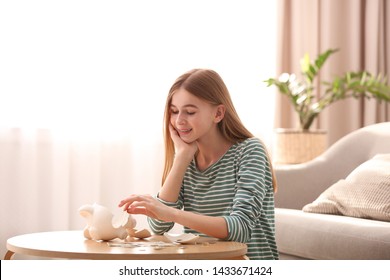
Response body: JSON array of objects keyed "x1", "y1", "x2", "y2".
[{"x1": 0, "y1": 0, "x2": 276, "y2": 256}]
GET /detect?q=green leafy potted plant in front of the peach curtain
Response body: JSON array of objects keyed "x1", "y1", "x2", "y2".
[{"x1": 264, "y1": 49, "x2": 390, "y2": 163}]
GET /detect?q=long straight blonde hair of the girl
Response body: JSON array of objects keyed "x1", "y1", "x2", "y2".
[{"x1": 162, "y1": 69, "x2": 276, "y2": 192}]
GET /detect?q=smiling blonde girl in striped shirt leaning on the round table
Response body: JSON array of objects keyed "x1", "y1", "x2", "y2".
[{"x1": 119, "y1": 69, "x2": 278, "y2": 259}]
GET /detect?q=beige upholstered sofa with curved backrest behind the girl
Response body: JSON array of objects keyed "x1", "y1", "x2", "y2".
[{"x1": 275, "y1": 122, "x2": 390, "y2": 260}]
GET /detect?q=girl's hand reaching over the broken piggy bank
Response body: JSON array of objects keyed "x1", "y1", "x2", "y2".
[{"x1": 118, "y1": 195, "x2": 176, "y2": 222}]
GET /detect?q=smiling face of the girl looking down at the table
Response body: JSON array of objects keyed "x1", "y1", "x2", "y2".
[{"x1": 170, "y1": 88, "x2": 224, "y2": 143}]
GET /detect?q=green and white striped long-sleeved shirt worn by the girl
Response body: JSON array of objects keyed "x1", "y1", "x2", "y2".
[{"x1": 148, "y1": 138, "x2": 278, "y2": 259}]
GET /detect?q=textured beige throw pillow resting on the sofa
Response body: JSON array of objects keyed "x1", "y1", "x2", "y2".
[{"x1": 303, "y1": 154, "x2": 390, "y2": 221}]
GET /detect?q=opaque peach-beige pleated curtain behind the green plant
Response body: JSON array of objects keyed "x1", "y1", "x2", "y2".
[{"x1": 275, "y1": 0, "x2": 390, "y2": 144}]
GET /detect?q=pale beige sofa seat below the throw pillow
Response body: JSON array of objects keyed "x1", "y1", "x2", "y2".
[{"x1": 275, "y1": 208, "x2": 390, "y2": 260}]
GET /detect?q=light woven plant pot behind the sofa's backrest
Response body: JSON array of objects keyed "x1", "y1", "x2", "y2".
[{"x1": 272, "y1": 128, "x2": 328, "y2": 164}]
